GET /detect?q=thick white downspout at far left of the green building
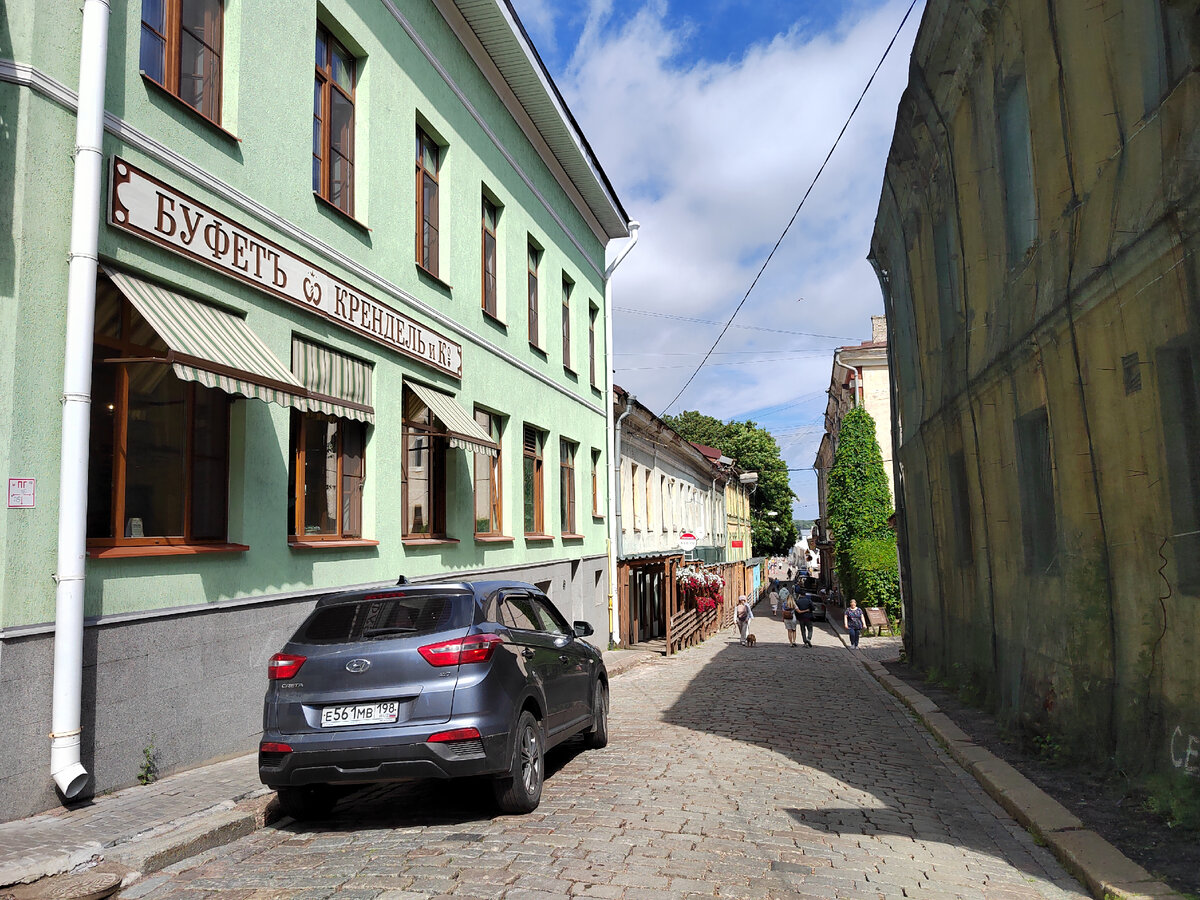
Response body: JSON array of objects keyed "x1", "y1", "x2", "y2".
[{"x1": 50, "y1": 0, "x2": 109, "y2": 800}]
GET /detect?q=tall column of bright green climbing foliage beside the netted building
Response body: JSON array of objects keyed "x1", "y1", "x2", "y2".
[{"x1": 828, "y1": 407, "x2": 900, "y2": 617}]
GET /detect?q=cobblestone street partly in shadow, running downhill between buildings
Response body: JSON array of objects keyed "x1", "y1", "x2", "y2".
[{"x1": 121, "y1": 617, "x2": 1086, "y2": 900}]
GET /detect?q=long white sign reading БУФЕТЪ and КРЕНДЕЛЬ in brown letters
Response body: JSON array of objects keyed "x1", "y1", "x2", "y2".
[{"x1": 108, "y1": 156, "x2": 462, "y2": 378}]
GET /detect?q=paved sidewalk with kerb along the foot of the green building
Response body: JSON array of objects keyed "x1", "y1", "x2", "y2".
[{"x1": 0, "y1": 650, "x2": 660, "y2": 900}]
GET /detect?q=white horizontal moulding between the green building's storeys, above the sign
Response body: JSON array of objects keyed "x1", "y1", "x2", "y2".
[{"x1": 0, "y1": 59, "x2": 605, "y2": 415}]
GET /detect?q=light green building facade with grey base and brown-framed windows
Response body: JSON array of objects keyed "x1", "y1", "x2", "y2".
[{"x1": 0, "y1": 0, "x2": 629, "y2": 818}]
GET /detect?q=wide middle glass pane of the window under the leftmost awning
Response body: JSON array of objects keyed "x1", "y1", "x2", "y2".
[{"x1": 122, "y1": 364, "x2": 187, "y2": 538}]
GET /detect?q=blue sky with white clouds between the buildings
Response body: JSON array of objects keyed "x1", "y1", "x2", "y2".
[{"x1": 514, "y1": 0, "x2": 922, "y2": 518}]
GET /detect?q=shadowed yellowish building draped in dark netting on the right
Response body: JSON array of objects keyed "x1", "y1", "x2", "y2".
[{"x1": 871, "y1": 0, "x2": 1200, "y2": 775}]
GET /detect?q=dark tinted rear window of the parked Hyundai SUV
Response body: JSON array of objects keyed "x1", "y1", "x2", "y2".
[{"x1": 292, "y1": 594, "x2": 470, "y2": 643}]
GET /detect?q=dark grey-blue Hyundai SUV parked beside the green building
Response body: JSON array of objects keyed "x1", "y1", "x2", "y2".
[{"x1": 258, "y1": 578, "x2": 608, "y2": 818}]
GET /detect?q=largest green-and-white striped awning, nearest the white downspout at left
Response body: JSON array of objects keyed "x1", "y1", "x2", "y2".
[{"x1": 104, "y1": 266, "x2": 308, "y2": 409}]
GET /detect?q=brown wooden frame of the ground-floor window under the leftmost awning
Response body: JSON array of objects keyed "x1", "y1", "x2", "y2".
[{"x1": 86, "y1": 282, "x2": 231, "y2": 553}]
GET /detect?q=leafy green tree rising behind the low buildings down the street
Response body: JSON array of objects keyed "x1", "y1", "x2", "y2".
[{"x1": 664, "y1": 409, "x2": 796, "y2": 556}]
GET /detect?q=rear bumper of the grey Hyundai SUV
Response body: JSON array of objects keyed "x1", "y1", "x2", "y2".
[{"x1": 258, "y1": 721, "x2": 510, "y2": 788}]
